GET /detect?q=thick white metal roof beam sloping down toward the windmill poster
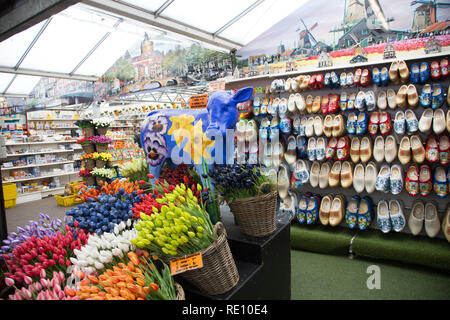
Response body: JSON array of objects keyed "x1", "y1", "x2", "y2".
[{"x1": 83, "y1": 0, "x2": 243, "y2": 51}]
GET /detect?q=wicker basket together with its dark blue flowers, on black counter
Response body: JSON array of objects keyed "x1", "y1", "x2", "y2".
[{"x1": 208, "y1": 164, "x2": 278, "y2": 237}]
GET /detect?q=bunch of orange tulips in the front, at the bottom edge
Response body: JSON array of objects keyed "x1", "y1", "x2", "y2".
[{"x1": 76, "y1": 250, "x2": 176, "y2": 300}]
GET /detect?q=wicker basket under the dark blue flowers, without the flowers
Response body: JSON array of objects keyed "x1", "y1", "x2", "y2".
[{"x1": 229, "y1": 182, "x2": 278, "y2": 237}]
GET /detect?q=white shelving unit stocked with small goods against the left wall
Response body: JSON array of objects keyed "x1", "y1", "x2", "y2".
[{"x1": 1, "y1": 110, "x2": 83, "y2": 204}]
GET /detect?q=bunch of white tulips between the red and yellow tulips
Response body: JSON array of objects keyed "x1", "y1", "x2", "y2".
[{"x1": 70, "y1": 219, "x2": 137, "y2": 274}]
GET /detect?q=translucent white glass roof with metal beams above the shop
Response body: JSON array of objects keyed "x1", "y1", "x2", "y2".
[{"x1": 0, "y1": 0, "x2": 307, "y2": 96}]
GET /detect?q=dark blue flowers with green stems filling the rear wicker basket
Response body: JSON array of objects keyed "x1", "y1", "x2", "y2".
[{"x1": 208, "y1": 164, "x2": 270, "y2": 203}]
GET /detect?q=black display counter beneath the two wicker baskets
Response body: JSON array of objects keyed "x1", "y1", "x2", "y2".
[{"x1": 175, "y1": 206, "x2": 291, "y2": 300}]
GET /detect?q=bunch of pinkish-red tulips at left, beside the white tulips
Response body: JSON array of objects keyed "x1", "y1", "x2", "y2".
[{"x1": 3, "y1": 222, "x2": 89, "y2": 284}]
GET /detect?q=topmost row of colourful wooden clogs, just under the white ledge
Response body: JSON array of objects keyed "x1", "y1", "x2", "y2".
[{"x1": 268, "y1": 58, "x2": 449, "y2": 93}]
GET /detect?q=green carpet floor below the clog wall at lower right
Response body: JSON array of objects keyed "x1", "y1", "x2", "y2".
[{"x1": 291, "y1": 250, "x2": 450, "y2": 300}]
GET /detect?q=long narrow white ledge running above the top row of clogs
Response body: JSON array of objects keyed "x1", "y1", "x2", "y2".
[{"x1": 225, "y1": 47, "x2": 450, "y2": 84}]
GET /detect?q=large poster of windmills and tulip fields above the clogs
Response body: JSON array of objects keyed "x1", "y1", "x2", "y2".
[{"x1": 237, "y1": 0, "x2": 450, "y2": 68}]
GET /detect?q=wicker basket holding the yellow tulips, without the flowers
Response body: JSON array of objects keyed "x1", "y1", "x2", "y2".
[{"x1": 174, "y1": 222, "x2": 239, "y2": 295}]
